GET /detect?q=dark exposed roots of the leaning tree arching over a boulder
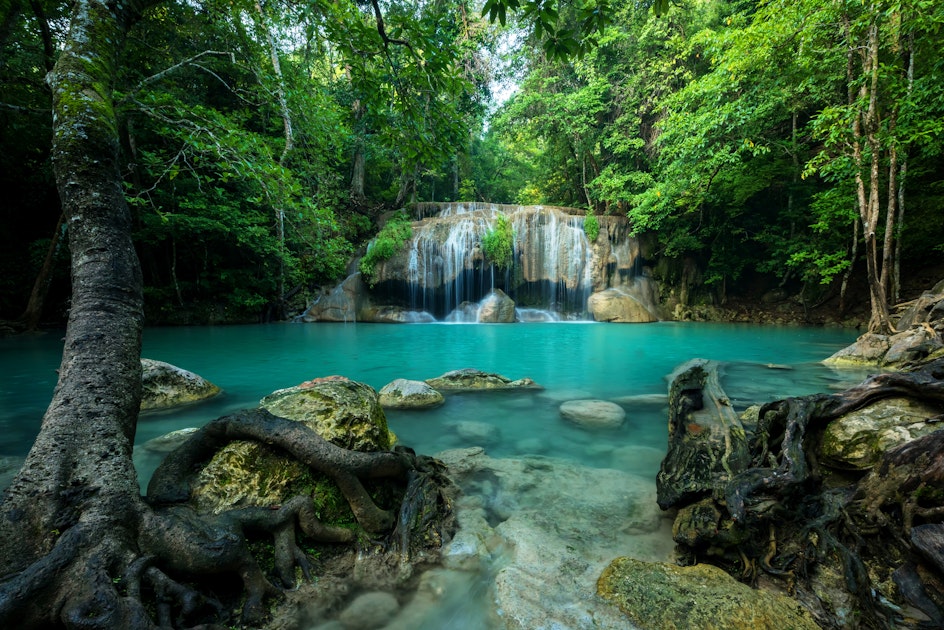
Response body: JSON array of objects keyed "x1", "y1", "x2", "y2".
[{"x1": 0, "y1": 410, "x2": 451, "y2": 629}]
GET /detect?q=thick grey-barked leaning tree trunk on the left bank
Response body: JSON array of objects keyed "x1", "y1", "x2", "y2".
[{"x1": 0, "y1": 0, "x2": 150, "y2": 627}]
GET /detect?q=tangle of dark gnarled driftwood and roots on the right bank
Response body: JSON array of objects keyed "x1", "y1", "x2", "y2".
[{"x1": 659, "y1": 359, "x2": 944, "y2": 628}]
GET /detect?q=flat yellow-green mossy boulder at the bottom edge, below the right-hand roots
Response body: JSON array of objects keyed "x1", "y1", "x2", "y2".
[{"x1": 597, "y1": 558, "x2": 819, "y2": 630}]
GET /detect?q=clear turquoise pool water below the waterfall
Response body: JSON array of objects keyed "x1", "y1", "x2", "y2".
[{"x1": 0, "y1": 322, "x2": 860, "y2": 476}]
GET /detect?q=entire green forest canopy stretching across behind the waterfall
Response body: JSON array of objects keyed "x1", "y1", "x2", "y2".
[{"x1": 0, "y1": 0, "x2": 944, "y2": 327}]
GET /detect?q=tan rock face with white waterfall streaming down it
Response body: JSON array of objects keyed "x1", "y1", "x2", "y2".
[{"x1": 304, "y1": 203, "x2": 659, "y2": 322}]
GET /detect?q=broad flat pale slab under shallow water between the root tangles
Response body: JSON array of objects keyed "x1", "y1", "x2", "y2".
[{"x1": 437, "y1": 448, "x2": 672, "y2": 630}]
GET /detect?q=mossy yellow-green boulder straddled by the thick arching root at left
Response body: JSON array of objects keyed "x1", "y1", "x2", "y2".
[{"x1": 192, "y1": 376, "x2": 391, "y2": 522}]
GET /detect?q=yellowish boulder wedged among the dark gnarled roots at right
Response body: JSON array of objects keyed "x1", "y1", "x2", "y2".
[{"x1": 819, "y1": 398, "x2": 942, "y2": 470}]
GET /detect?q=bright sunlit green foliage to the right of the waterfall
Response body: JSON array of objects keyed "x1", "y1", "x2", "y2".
[{"x1": 482, "y1": 0, "x2": 944, "y2": 326}]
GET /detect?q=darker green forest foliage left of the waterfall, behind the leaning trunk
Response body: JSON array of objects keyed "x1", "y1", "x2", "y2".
[{"x1": 0, "y1": 0, "x2": 492, "y2": 323}]
